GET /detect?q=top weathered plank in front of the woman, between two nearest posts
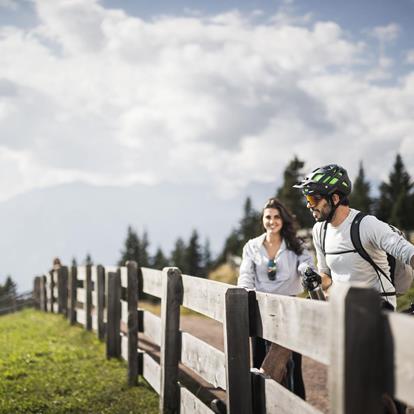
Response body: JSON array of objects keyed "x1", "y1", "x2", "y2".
[{"x1": 254, "y1": 292, "x2": 329, "y2": 365}]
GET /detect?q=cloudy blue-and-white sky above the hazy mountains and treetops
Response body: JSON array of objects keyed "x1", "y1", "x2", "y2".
[{"x1": 0, "y1": 0, "x2": 414, "y2": 290}]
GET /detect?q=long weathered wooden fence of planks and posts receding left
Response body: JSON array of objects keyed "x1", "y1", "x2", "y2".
[{"x1": 35, "y1": 262, "x2": 414, "y2": 414}]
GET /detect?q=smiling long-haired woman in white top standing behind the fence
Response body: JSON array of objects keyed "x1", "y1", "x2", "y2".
[{"x1": 237, "y1": 198, "x2": 314, "y2": 398}]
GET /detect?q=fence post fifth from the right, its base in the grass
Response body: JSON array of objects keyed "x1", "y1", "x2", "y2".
[{"x1": 106, "y1": 271, "x2": 121, "y2": 358}]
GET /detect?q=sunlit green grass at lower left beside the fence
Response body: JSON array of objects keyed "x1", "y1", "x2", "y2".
[{"x1": 0, "y1": 310, "x2": 158, "y2": 414}]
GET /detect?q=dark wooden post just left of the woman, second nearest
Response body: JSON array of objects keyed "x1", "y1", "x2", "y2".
[{"x1": 224, "y1": 288, "x2": 252, "y2": 414}]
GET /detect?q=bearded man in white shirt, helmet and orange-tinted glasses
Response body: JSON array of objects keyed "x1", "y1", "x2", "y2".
[{"x1": 294, "y1": 164, "x2": 414, "y2": 309}]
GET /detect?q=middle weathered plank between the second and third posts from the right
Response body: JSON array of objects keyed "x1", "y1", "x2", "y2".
[{"x1": 181, "y1": 332, "x2": 226, "y2": 390}]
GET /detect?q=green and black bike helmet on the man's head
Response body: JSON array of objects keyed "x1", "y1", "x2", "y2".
[{"x1": 294, "y1": 164, "x2": 352, "y2": 196}]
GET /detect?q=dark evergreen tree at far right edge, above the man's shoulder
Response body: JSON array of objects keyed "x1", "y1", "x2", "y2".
[{"x1": 376, "y1": 154, "x2": 414, "y2": 230}]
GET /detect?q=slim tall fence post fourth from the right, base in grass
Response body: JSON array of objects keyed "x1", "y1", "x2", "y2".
[{"x1": 126, "y1": 261, "x2": 138, "y2": 386}]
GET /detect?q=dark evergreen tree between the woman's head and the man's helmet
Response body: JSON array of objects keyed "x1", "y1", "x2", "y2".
[{"x1": 276, "y1": 156, "x2": 314, "y2": 228}]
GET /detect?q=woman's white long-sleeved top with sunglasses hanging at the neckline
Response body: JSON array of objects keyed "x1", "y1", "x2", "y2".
[{"x1": 237, "y1": 233, "x2": 315, "y2": 295}]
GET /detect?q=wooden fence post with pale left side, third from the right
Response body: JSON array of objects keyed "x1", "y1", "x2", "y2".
[{"x1": 160, "y1": 267, "x2": 183, "y2": 414}]
